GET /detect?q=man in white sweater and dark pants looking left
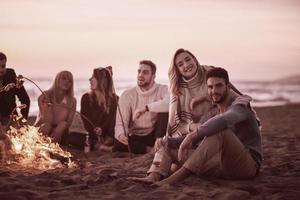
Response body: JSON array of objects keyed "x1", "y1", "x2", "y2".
[{"x1": 113, "y1": 60, "x2": 169, "y2": 153}]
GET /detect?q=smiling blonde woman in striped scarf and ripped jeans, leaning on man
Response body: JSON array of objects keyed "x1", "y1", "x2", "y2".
[{"x1": 130, "y1": 49, "x2": 248, "y2": 183}]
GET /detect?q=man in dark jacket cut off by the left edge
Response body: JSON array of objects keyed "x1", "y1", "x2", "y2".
[{"x1": 0, "y1": 52, "x2": 30, "y2": 126}]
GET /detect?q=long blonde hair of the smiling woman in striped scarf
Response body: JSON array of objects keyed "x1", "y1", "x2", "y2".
[{"x1": 168, "y1": 48, "x2": 201, "y2": 96}]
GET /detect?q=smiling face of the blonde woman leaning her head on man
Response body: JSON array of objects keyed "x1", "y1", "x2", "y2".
[{"x1": 175, "y1": 52, "x2": 197, "y2": 80}]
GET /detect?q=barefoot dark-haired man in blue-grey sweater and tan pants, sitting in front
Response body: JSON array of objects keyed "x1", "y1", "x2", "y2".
[{"x1": 131, "y1": 68, "x2": 262, "y2": 185}]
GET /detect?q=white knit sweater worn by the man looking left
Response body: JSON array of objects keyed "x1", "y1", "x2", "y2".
[{"x1": 115, "y1": 83, "x2": 169, "y2": 139}]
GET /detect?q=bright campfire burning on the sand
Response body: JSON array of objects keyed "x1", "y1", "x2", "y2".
[{"x1": 2, "y1": 119, "x2": 76, "y2": 170}]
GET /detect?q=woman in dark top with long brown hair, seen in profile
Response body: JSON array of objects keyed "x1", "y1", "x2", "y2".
[{"x1": 80, "y1": 67, "x2": 118, "y2": 150}]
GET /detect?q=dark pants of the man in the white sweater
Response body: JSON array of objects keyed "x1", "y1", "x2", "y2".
[{"x1": 113, "y1": 113, "x2": 168, "y2": 154}]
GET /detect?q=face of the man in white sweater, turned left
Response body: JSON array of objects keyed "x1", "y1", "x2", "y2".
[{"x1": 137, "y1": 64, "x2": 155, "y2": 89}]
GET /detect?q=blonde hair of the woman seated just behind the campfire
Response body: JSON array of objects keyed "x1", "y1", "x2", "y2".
[{"x1": 46, "y1": 71, "x2": 74, "y2": 105}]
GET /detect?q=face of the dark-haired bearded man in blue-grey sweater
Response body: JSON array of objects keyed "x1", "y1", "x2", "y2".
[{"x1": 207, "y1": 77, "x2": 230, "y2": 104}]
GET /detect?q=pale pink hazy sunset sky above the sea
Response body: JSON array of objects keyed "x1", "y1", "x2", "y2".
[{"x1": 0, "y1": 0, "x2": 300, "y2": 80}]
